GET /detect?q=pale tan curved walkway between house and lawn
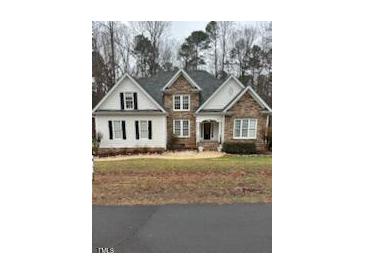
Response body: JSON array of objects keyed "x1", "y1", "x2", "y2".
[{"x1": 94, "y1": 151, "x2": 225, "y2": 161}]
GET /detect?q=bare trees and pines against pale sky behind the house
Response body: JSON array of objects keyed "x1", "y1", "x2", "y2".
[{"x1": 92, "y1": 21, "x2": 272, "y2": 106}]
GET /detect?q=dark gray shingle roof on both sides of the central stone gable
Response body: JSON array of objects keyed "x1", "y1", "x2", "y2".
[{"x1": 134, "y1": 70, "x2": 225, "y2": 106}]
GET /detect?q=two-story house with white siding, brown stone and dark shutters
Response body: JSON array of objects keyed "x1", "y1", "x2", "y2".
[{"x1": 92, "y1": 69, "x2": 272, "y2": 152}]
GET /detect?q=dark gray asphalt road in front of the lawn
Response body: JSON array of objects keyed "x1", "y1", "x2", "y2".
[{"x1": 92, "y1": 204, "x2": 272, "y2": 253}]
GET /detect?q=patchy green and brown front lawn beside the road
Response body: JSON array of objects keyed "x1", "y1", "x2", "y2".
[{"x1": 93, "y1": 156, "x2": 272, "y2": 205}]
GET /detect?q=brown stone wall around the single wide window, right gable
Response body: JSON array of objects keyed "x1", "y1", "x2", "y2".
[{"x1": 224, "y1": 92, "x2": 268, "y2": 152}]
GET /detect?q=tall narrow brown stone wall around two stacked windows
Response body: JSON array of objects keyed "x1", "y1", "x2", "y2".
[{"x1": 163, "y1": 76, "x2": 200, "y2": 149}]
